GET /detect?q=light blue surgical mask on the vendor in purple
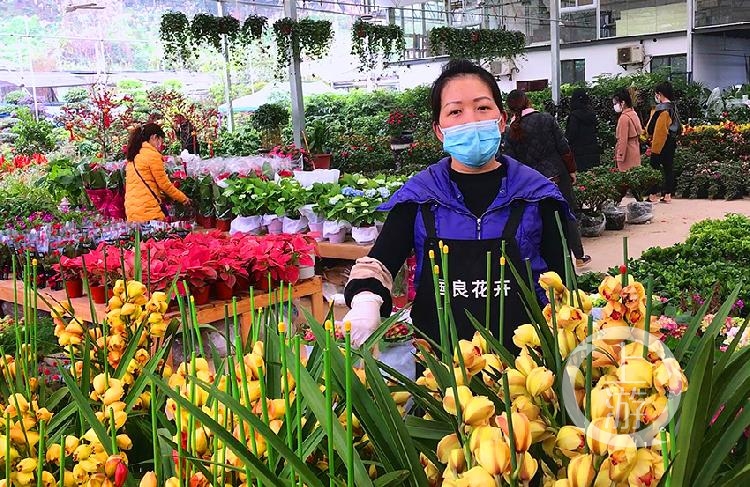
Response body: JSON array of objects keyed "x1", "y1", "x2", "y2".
[{"x1": 440, "y1": 120, "x2": 500, "y2": 167}]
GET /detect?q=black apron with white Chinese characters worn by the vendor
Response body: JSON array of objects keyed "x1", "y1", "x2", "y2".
[{"x1": 411, "y1": 201, "x2": 529, "y2": 354}]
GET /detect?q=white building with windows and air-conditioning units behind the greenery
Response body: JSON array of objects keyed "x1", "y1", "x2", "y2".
[{"x1": 376, "y1": 0, "x2": 750, "y2": 91}]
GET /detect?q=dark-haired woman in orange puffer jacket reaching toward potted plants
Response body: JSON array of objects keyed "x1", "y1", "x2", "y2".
[{"x1": 125, "y1": 123, "x2": 190, "y2": 222}]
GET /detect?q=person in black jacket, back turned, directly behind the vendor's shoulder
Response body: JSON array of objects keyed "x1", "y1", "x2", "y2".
[{"x1": 504, "y1": 90, "x2": 591, "y2": 267}]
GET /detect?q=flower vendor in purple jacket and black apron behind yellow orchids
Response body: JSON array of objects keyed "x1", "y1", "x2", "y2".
[{"x1": 344, "y1": 60, "x2": 573, "y2": 350}]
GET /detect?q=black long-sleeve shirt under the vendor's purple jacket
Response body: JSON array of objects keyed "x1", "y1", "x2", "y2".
[{"x1": 344, "y1": 165, "x2": 566, "y2": 316}]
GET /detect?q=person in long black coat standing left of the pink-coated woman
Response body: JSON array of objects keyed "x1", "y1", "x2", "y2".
[{"x1": 565, "y1": 88, "x2": 601, "y2": 171}]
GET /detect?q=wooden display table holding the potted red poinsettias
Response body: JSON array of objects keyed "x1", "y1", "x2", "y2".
[{"x1": 0, "y1": 276, "x2": 328, "y2": 339}]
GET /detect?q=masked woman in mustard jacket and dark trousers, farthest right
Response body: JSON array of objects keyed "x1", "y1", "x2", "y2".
[{"x1": 646, "y1": 81, "x2": 682, "y2": 203}]
